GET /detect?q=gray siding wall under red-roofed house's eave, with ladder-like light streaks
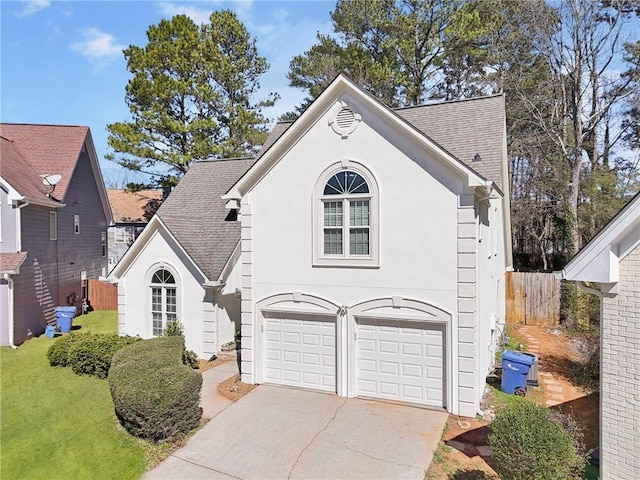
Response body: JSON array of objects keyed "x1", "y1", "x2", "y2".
[{"x1": 14, "y1": 205, "x2": 58, "y2": 344}]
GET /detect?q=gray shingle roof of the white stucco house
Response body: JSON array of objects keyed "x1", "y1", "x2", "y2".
[{"x1": 157, "y1": 95, "x2": 507, "y2": 280}]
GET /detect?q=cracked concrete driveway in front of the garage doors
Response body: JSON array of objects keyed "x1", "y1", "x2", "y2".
[{"x1": 144, "y1": 385, "x2": 447, "y2": 480}]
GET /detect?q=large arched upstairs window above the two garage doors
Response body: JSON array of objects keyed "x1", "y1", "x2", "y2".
[{"x1": 314, "y1": 161, "x2": 378, "y2": 266}]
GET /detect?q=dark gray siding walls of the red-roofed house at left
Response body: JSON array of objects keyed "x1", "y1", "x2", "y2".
[{"x1": 14, "y1": 146, "x2": 107, "y2": 344}]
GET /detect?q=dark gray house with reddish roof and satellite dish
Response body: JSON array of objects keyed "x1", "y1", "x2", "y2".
[{"x1": 0, "y1": 123, "x2": 111, "y2": 345}]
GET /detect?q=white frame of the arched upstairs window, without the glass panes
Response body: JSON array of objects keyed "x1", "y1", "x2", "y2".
[{"x1": 313, "y1": 159, "x2": 380, "y2": 268}]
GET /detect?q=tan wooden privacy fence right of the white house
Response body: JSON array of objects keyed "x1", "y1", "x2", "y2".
[{"x1": 505, "y1": 272, "x2": 560, "y2": 325}]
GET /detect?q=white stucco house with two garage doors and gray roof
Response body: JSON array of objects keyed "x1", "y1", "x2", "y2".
[{"x1": 111, "y1": 76, "x2": 511, "y2": 416}]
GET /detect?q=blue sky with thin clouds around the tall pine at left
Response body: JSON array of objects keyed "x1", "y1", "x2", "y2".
[{"x1": 0, "y1": 0, "x2": 335, "y2": 186}]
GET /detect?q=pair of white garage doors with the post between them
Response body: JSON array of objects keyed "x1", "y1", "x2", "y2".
[{"x1": 261, "y1": 298, "x2": 446, "y2": 408}]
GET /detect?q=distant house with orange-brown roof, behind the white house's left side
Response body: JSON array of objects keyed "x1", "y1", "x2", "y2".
[{"x1": 107, "y1": 188, "x2": 162, "y2": 271}]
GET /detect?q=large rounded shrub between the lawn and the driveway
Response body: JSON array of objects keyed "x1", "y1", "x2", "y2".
[{"x1": 109, "y1": 336, "x2": 202, "y2": 441}]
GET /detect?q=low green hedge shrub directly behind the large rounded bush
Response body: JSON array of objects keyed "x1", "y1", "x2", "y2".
[{"x1": 67, "y1": 333, "x2": 140, "y2": 378}]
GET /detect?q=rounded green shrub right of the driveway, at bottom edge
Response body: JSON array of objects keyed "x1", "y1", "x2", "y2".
[{"x1": 489, "y1": 401, "x2": 586, "y2": 480}]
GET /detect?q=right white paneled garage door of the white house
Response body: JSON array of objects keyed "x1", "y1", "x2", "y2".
[{"x1": 356, "y1": 319, "x2": 445, "y2": 407}]
